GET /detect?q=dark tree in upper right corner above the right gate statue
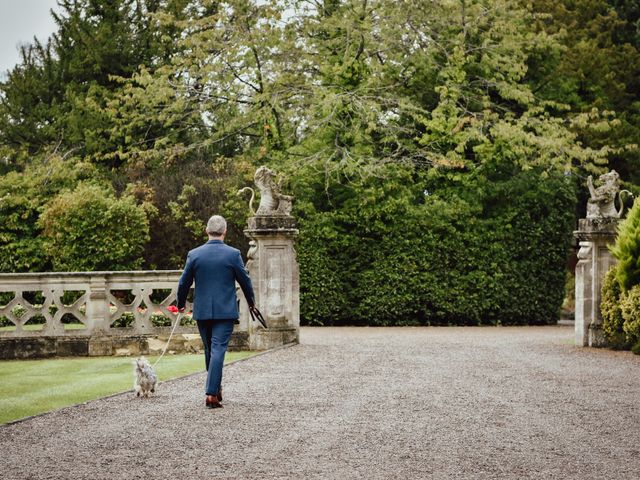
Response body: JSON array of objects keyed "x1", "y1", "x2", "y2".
[{"x1": 528, "y1": 0, "x2": 640, "y2": 186}]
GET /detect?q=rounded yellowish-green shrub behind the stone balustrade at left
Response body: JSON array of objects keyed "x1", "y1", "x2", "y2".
[{"x1": 40, "y1": 184, "x2": 149, "y2": 271}]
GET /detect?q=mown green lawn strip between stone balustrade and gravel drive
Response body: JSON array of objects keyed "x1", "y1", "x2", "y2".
[{"x1": 0, "y1": 352, "x2": 252, "y2": 424}]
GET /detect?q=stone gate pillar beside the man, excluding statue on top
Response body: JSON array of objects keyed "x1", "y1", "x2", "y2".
[{"x1": 241, "y1": 215, "x2": 300, "y2": 350}]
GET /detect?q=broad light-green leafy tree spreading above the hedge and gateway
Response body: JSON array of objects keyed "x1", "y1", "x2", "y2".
[{"x1": 110, "y1": 0, "x2": 609, "y2": 182}]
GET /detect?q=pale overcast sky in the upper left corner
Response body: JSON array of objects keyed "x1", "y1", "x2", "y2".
[{"x1": 0, "y1": 0, "x2": 57, "y2": 77}]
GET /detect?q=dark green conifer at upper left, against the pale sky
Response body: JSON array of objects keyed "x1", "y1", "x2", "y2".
[{"x1": 0, "y1": 0, "x2": 188, "y2": 167}]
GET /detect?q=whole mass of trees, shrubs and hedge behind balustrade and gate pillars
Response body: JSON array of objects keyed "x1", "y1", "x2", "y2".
[{"x1": 0, "y1": 0, "x2": 640, "y2": 325}]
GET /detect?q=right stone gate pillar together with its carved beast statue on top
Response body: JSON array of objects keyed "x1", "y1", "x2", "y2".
[{"x1": 573, "y1": 170, "x2": 622, "y2": 347}]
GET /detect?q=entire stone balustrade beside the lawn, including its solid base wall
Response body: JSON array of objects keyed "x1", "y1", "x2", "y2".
[{"x1": 0, "y1": 270, "x2": 249, "y2": 358}]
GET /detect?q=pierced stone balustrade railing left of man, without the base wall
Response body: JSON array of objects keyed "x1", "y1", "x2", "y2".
[{"x1": 0, "y1": 270, "x2": 208, "y2": 337}]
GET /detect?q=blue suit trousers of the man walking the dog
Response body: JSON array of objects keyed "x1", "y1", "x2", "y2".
[{"x1": 197, "y1": 320, "x2": 233, "y2": 395}]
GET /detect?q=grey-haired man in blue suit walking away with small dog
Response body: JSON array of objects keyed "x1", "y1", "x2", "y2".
[{"x1": 178, "y1": 215, "x2": 255, "y2": 408}]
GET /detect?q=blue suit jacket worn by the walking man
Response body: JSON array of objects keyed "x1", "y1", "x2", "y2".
[{"x1": 178, "y1": 240, "x2": 255, "y2": 320}]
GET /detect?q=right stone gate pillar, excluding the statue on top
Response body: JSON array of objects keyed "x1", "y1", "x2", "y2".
[{"x1": 573, "y1": 217, "x2": 618, "y2": 347}]
